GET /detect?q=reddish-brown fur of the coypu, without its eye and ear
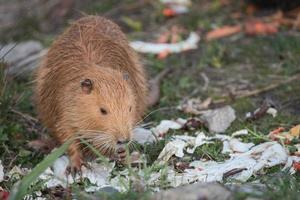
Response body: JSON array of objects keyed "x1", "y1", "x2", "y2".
[{"x1": 35, "y1": 16, "x2": 147, "y2": 167}]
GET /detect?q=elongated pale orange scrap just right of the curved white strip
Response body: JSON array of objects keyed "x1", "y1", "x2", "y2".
[{"x1": 205, "y1": 25, "x2": 242, "y2": 41}]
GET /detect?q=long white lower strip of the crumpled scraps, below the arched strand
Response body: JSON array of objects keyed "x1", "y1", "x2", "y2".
[{"x1": 167, "y1": 142, "x2": 288, "y2": 187}]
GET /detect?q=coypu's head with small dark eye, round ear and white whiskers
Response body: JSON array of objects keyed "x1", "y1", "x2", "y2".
[{"x1": 67, "y1": 67, "x2": 138, "y2": 155}]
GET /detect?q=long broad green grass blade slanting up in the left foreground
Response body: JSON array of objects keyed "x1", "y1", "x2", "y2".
[{"x1": 9, "y1": 140, "x2": 71, "y2": 200}]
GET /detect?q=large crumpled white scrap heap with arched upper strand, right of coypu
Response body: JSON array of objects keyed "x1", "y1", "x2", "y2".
[{"x1": 158, "y1": 130, "x2": 291, "y2": 187}]
